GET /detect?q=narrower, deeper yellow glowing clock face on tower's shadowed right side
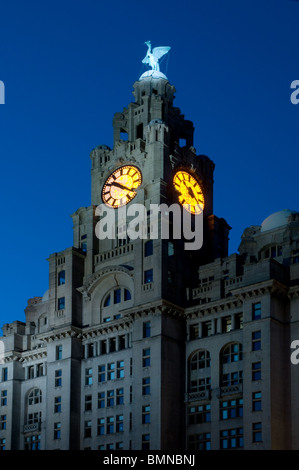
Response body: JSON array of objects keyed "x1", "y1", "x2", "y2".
[{"x1": 173, "y1": 170, "x2": 204, "y2": 214}]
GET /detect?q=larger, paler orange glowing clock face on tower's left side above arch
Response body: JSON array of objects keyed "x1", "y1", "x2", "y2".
[{"x1": 102, "y1": 165, "x2": 142, "y2": 209}]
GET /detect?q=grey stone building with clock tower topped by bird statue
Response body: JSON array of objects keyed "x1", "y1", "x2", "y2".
[{"x1": 0, "y1": 43, "x2": 299, "y2": 451}]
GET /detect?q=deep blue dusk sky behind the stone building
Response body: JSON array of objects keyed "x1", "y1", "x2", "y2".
[{"x1": 0, "y1": 0, "x2": 299, "y2": 327}]
